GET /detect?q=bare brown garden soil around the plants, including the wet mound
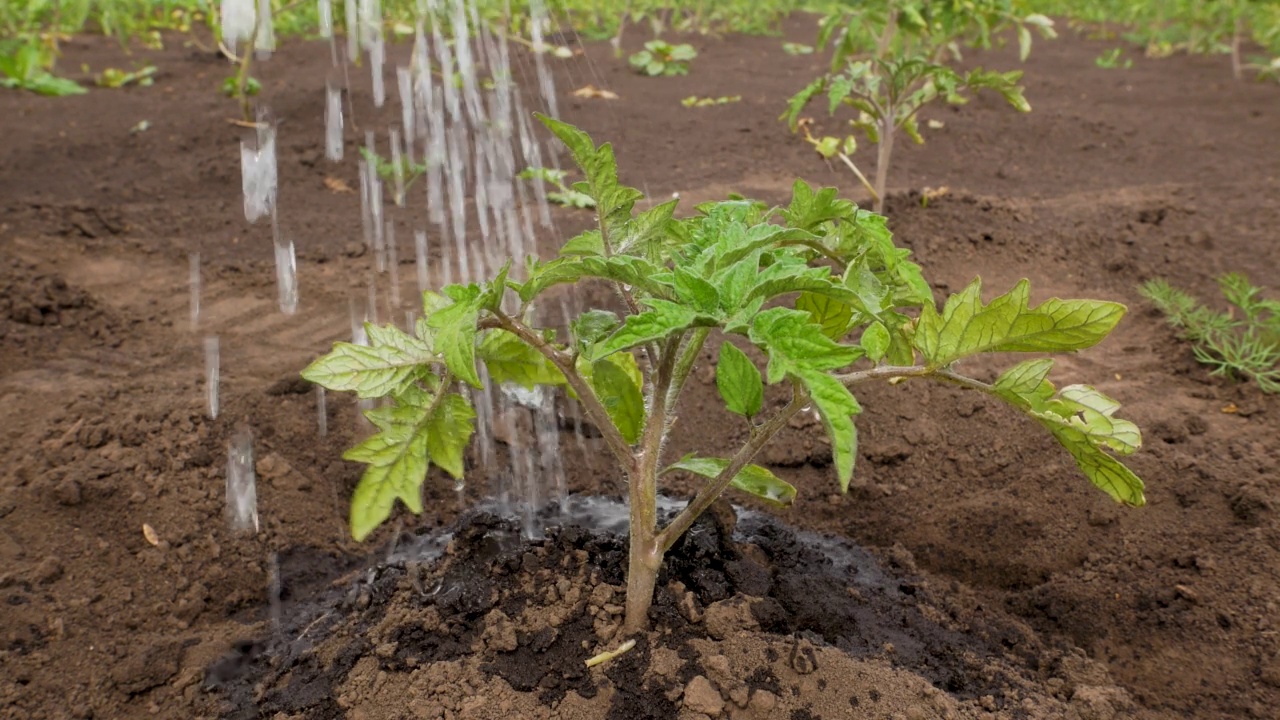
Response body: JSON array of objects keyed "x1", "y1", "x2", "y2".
[{"x1": 0, "y1": 14, "x2": 1280, "y2": 720}]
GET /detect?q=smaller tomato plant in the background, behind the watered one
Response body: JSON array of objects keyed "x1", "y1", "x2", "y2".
[{"x1": 780, "y1": 0, "x2": 1053, "y2": 213}]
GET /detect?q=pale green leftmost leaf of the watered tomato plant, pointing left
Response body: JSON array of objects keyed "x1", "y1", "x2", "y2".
[{"x1": 302, "y1": 324, "x2": 436, "y2": 398}]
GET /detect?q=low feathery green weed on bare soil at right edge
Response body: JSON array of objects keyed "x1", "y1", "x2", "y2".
[{"x1": 1139, "y1": 273, "x2": 1280, "y2": 393}]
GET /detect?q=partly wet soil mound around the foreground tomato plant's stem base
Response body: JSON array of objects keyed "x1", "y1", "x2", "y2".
[{"x1": 206, "y1": 506, "x2": 1130, "y2": 720}]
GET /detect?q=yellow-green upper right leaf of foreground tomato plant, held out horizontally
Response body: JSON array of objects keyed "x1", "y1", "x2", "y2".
[{"x1": 914, "y1": 274, "x2": 1125, "y2": 365}]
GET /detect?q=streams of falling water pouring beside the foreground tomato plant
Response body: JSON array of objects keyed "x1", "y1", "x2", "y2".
[{"x1": 224, "y1": 0, "x2": 604, "y2": 537}]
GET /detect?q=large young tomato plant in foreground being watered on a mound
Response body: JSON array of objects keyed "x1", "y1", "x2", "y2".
[{"x1": 302, "y1": 118, "x2": 1144, "y2": 633}]
